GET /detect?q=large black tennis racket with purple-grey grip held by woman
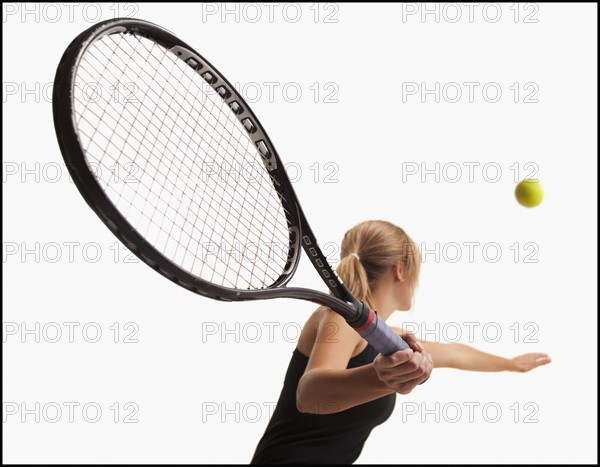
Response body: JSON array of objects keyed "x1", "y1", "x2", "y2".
[{"x1": 53, "y1": 18, "x2": 408, "y2": 355}]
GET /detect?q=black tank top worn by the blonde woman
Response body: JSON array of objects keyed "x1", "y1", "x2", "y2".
[{"x1": 251, "y1": 345, "x2": 396, "y2": 464}]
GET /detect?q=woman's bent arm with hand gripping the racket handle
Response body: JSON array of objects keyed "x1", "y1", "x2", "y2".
[{"x1": 296, "y1": 311, "x2": 432, "y2": 414}]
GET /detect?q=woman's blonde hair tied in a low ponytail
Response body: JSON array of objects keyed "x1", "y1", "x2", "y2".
[{"x1": 336, "y1": 220, "x2": 421, "y2": 306}]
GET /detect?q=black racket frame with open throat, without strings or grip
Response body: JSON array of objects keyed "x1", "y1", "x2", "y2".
[{"x1": 53, "y1": 18, "x2": 370, "y2": 328}]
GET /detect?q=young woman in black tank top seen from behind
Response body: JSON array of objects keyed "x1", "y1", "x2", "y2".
[{"x1": 251, "y1": 221, "x2": 550, "y2": 464}]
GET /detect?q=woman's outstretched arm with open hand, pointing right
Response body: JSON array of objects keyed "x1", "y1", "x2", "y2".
[{"x1": 421, "y1": 341, "x2": 551, "y2": 372}]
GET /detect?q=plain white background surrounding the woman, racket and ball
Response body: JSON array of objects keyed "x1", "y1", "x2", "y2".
[{"x1": 3, "y1": 3, "x2": 598, "y2": 463}]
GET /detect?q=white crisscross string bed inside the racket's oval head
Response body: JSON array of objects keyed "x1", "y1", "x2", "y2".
[{"x1": 74, "y1": 34, "x2": 289, "y2": 288}]
